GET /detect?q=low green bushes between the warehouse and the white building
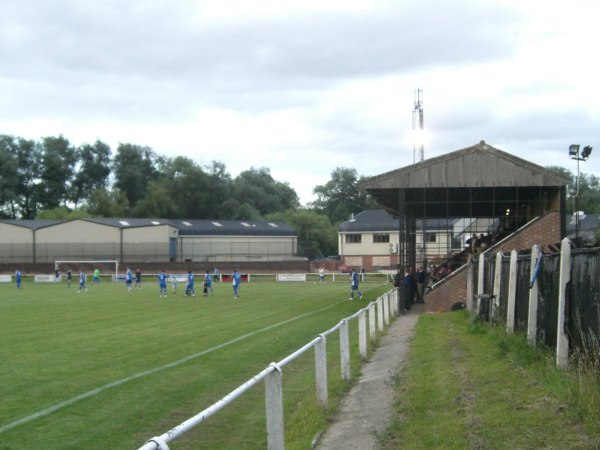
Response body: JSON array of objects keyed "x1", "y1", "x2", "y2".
[{"x1": 267, "y1": 209, "x2": 338, "y2": 258}]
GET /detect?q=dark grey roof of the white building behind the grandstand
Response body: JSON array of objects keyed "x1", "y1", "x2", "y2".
[{"x1": 339, "y1": 209, "x2": 454, "y2": 233}]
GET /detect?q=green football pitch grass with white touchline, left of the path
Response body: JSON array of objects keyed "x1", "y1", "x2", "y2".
[{"x1": 0, "y1": 279, "x2": 391, "y2": 450}]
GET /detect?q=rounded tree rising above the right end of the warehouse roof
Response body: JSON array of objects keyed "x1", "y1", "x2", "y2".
[{"x1": 233, "y1": 167, "x2": 300, "y2": 216}]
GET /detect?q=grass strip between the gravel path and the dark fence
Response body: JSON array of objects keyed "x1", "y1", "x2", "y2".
[{"x1": 383, "y1": 312, "x2": 600, "y2": 449}]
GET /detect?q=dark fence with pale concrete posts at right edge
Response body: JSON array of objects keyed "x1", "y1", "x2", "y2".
[{"x1": 468, "y1": 238, "x2": 600, "y2": 367}]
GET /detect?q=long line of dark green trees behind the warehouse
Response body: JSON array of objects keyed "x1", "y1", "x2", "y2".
[{"x1": 0, "y1": 135, "x2": 377, "y2": 256}]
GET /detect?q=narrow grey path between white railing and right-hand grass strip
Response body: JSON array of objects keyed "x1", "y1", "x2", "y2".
[{"x1": 314, "y1": 304, "x2": 423, "y2": 450}]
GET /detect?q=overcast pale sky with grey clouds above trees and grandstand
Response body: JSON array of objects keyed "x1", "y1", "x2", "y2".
[{"x1": 0, "y1": 0, "x2": 600, "y2": 203}]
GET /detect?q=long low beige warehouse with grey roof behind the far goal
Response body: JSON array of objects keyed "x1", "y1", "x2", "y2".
[{"x1": 0, "y1": 219, "x2": 304, "y2": 264}]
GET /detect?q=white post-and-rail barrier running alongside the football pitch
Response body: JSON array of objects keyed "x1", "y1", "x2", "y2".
[{"x1": 139, "y1": 289, "x2": 399, "y2": 450}]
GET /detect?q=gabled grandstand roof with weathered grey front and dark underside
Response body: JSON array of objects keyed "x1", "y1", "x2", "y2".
[{"x1": 362, "y1": 141, "x2": 569, "y2": 217}]
